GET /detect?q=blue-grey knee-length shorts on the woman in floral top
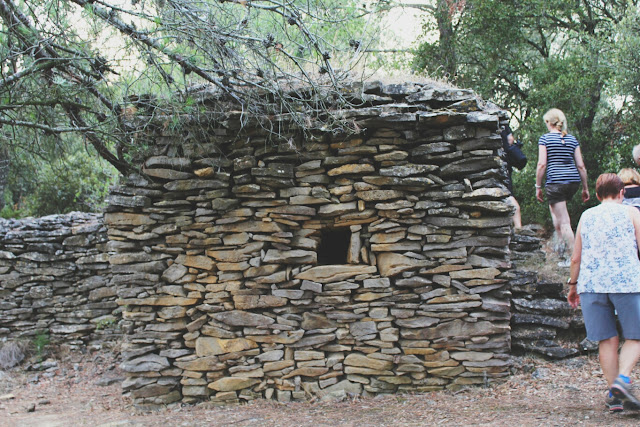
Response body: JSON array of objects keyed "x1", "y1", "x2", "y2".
[{"x1": 580, "y1": 293, "x2": 640, "y2": 341}]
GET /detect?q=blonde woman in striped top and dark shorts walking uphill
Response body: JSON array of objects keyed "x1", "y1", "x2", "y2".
[{"x1": 536, "y1": 108, "x2": 589, "y2": 267}]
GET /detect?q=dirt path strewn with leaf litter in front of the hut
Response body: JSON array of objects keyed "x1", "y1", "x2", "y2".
[{"x1": 0, "y1": 355, "x2": 640, "y2": 427}]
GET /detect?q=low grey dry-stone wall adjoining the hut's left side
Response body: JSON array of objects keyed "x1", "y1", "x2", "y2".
[{"x1": 0, "y1": 213, "x2": 120, "y2": 347}]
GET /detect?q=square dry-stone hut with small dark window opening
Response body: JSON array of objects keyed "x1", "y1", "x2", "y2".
[{"x1": 105, "y1": 82, "x2": 511, "y2": 404}]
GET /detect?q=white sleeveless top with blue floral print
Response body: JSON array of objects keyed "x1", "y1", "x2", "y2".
[{"x1": 578, "y1": 202, "x2": 640, "y2": 294}]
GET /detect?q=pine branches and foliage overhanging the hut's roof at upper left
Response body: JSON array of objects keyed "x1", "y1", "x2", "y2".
[{"x1": 0, "y1": 0, "x2": 384, "y2": 215}]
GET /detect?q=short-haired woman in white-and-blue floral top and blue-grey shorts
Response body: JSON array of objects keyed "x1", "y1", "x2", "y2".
[{"x1": 567, "y1": 173, "x2": 640, "y2": 412}]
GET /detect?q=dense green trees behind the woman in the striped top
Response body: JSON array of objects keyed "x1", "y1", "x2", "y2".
[{"x1": 413, "y1": 0, "x2": 640, "y2": 225}]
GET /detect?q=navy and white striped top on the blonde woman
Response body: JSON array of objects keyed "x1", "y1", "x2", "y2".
[{"x1": 538, "y1": 132, "x2": 580, "y2": 184}]
